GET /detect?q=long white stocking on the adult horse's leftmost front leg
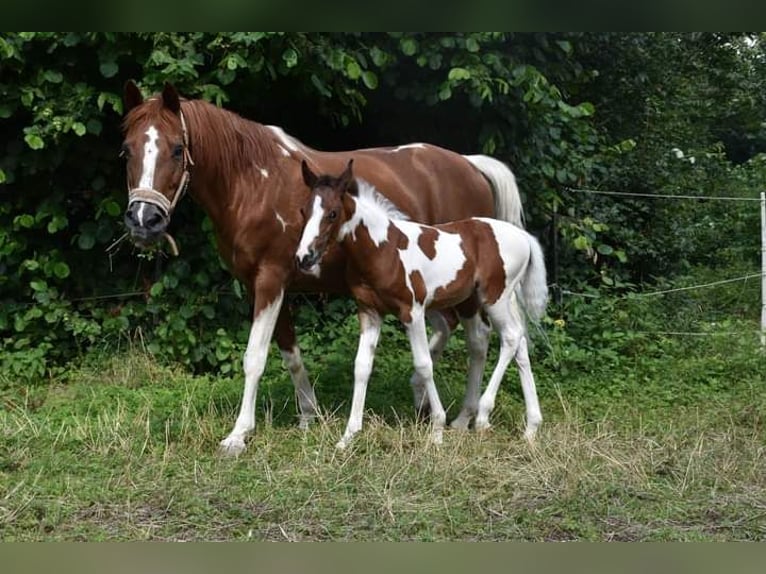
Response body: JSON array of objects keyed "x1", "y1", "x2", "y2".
[{"x1": 221, "y1": 291, "x2": 284, "y2": 455}]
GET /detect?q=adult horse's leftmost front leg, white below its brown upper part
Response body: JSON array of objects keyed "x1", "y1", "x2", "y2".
[{"x1": 221, "y1": 269, "x2": 285, "y2": 455}]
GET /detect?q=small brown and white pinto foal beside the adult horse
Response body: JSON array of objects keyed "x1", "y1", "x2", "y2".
[{"x1": 296, "y1": 160, "x2": 548, "y2": 448}]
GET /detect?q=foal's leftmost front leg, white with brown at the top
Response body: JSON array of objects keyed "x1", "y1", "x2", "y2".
[{"x1": 335, "y1": 308, "x2": 382, "y2": 449}]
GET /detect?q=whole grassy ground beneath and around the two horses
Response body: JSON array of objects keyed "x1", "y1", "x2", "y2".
[{"x1": 0, "y1": 312, "x2": 766, "y2": 541}]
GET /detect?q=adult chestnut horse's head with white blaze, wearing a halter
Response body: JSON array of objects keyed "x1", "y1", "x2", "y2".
[{"x1": 120, "y1": 81, "x2": 192, "y2": 247}]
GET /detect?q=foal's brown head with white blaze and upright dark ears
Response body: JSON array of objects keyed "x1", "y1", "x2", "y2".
[{"x1": 295, "y1": 159, "x2": 358, "y2": 276}]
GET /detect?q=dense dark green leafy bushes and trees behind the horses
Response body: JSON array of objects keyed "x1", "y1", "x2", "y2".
[{"x1": 0, "y1": 32, "x2": 766, "y2": 381}]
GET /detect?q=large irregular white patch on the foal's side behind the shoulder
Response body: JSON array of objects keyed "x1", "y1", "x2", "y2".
[{"x1": 394, "y1": 221, "x2": 466, "y2": 306}]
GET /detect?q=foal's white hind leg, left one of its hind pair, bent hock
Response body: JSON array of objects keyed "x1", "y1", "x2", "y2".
[{"x1": 474, "y1": 300, "x2": 524, "y2": 430}]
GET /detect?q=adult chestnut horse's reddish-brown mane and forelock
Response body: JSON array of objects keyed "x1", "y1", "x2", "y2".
[{"x1": 123, "y1": 97, "x2": 284, "y2": 181}]
